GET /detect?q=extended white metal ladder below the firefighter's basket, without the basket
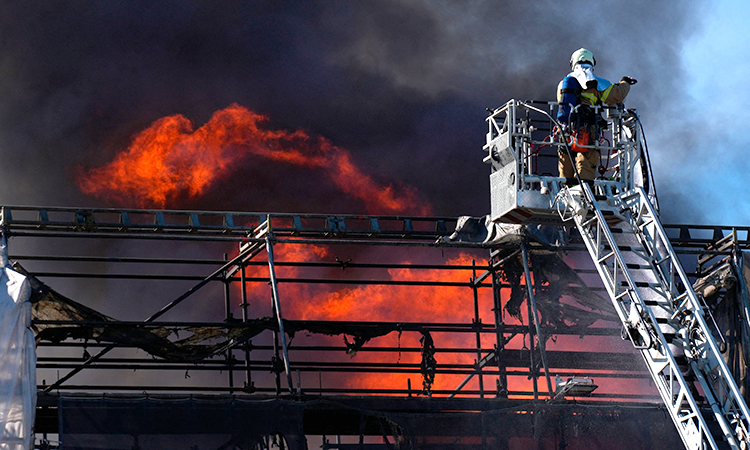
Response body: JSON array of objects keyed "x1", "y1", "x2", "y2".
[{"x1": 558, "y1": 183, "x2": 750, "y2": 450}]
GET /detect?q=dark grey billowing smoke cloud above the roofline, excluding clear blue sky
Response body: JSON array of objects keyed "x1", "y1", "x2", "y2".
[{"x1": 0, "y1": 1, "x2": 695, "y2": 220}]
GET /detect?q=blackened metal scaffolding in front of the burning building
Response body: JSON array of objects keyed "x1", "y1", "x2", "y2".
[{"x1": 0, "y1": 206, "x2": 750, "y2": 448}]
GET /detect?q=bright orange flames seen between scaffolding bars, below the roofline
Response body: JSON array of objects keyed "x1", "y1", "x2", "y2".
[{"x1": 242, "y1": 244, "x2": 494, "y2": 391}]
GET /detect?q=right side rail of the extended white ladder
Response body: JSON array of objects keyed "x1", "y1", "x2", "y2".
[{"x1": 638, "y1": 187, "x2": 750, "y2": 437}]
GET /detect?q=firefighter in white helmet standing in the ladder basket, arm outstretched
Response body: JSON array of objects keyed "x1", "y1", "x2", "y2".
[{"x1": 557, "y1": 48, "x2": 637, "y2": 180}]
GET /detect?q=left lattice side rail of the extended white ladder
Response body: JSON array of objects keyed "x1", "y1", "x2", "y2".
[{"x1": 574, "y1": 184, "x2": 724, "y2": 450}]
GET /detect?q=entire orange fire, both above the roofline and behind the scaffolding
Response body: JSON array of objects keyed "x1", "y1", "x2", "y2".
[{"x1": 79, "y1": 105, "x2": 648, "y2": 400}]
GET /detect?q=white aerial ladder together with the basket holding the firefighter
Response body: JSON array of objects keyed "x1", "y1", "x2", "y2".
[{"x1": 484, "y1": 100, "x2": 750, "y2": 450}]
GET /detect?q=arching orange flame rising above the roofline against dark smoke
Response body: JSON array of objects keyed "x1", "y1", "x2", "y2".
[{"x1": 78, "y1": 104, "x2": 430, "y2": 214}]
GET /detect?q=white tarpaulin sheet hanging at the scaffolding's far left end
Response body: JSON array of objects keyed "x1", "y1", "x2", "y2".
[{"x1": 0, "y1": 238, "x2": 36, "y2": 450}]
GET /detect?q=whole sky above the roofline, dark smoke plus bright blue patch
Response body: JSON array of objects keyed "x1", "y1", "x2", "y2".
[{"x1": 0, "y1": 0, "x2": 750, "y2": 225}]
